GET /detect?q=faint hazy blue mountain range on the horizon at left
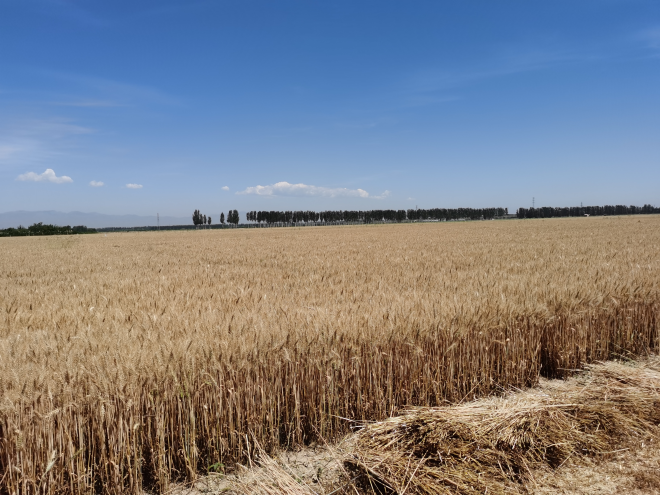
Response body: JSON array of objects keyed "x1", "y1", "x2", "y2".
[{"x1": 0, "y1": 210, "x2": 191, "y2": 229}]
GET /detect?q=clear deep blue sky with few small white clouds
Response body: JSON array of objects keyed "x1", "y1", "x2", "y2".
[{"x1": 0, "y1": 0, "x2": 660, "y2": 216}]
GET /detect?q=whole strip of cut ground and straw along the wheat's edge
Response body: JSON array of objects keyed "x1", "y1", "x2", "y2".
[{"x1": 233, "y1": 356, "x2": 660, "y2": 495}]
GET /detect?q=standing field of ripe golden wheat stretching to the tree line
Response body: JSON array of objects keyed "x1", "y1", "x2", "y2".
[{"x1": 0, "y1": 219, "x2": 660, "y2": 494}]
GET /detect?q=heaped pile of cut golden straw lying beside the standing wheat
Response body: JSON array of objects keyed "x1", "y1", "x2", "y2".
[{"x1": 347, "y1": 357, "x2": 660, "y2": 495}]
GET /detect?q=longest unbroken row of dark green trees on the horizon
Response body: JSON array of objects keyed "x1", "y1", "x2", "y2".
[{"x1": 247, "y1": 208, "x2": 508, "y2": 224}]
